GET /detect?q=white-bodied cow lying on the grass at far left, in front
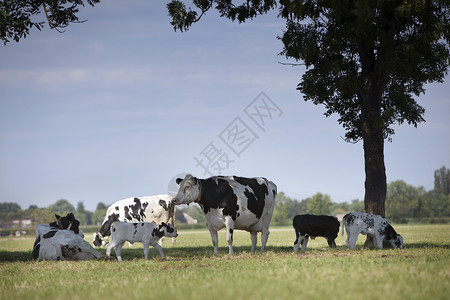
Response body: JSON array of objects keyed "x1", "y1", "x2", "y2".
[{"x1": 33, "y1": 224, "x2": 102, "y2": 261}]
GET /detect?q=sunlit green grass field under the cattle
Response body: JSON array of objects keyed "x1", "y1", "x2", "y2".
[{"x1": 0, "y1": 225, "x2": 450, "y2": 300}]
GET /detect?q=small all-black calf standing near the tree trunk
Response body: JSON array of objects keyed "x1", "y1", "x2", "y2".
[{"x1": 292, "y1": 214, "x2": 341, "y2": 251}]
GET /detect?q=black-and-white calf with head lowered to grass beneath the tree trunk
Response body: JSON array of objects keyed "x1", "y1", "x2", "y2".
[{"x1": 342, "y1": 212, "x2": 403, "y2": 249}]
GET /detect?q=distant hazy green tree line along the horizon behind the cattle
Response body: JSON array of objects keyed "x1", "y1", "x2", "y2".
[{"x1": 0, "y1": 167, "x2": 450, "y2": 225}]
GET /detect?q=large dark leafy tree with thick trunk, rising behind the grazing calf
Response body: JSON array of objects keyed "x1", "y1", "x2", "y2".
[{"x1": 167, "y1": 0, "x2": 450, "y2": 241}]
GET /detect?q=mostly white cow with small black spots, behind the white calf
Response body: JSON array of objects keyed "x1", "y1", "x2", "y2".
[{"x1": 93, "y1": 195, "x2": 176, "y2": 247}]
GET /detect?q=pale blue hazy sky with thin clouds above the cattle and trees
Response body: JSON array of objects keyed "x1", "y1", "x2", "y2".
[{"x1": 0, "y1": 0, "x2": 450, "y2": 211}]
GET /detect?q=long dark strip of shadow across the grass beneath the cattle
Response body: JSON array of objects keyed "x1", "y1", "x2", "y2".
[{"x1": 0, "y1": 243, "x2": 450, "y2": 263}]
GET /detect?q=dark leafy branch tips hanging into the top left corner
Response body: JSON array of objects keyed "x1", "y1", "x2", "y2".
[{"x1": 0, "y1": 0, "x2": 100, "y2": 45}]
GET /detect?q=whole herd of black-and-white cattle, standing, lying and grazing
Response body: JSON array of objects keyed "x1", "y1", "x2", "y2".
[{"x1": 33, "y1": 174, "x2": 403, "y2": 261}]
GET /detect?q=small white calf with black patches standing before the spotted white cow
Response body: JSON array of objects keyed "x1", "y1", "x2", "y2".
[{"x1": 106, "y1": 221, "x2": 178, "y2": 261}]
